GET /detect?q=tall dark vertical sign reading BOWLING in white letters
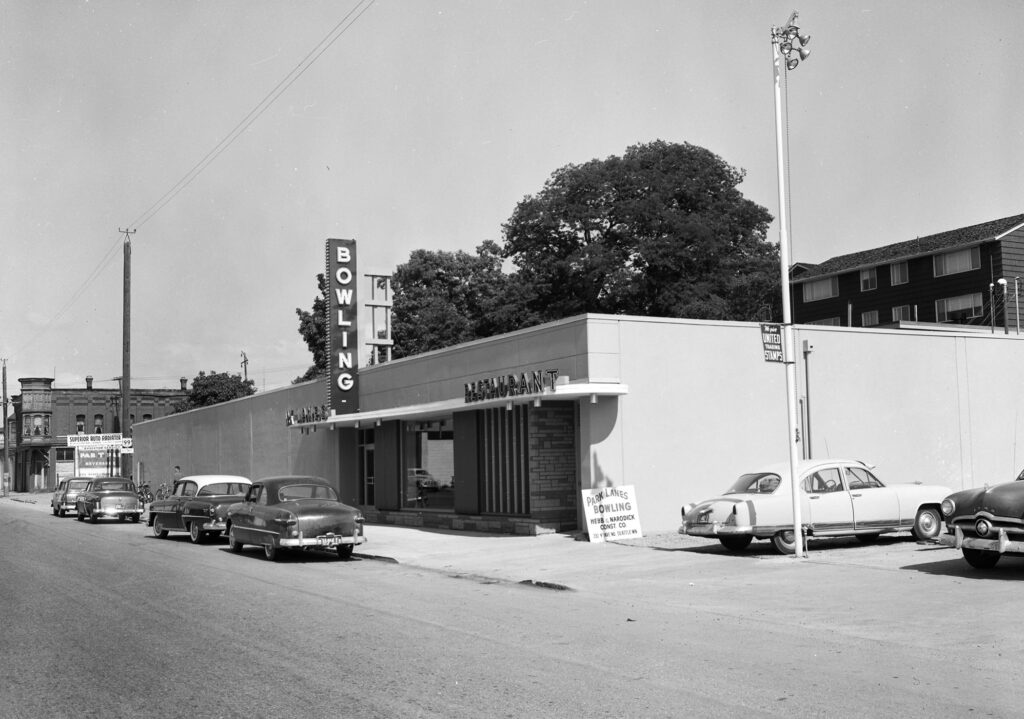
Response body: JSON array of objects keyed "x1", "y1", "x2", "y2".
[{"x1": 327, "y1": 239, "x2": 359, "y2": 415}]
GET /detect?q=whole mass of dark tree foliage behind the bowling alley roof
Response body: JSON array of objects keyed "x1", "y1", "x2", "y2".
[{"x1": 295, "y1": 140, "x2": 781, "y2": 366}]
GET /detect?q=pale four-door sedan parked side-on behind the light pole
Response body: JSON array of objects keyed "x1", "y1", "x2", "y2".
[{"x1": 679, "y1": 459, "x2": 949, "y2": 554}]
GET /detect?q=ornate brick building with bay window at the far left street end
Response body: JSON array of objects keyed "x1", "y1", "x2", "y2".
[{"x1": 7, "y1": 377, "x2": 187, "y2": 492}]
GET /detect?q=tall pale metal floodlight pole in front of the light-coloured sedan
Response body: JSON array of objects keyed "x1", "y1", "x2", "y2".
[{"x1": 771, "y1": 31, "x2": 806, "y2": 557}]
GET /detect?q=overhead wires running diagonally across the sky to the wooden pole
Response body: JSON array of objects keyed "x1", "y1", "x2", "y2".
[{"x1": 14, "y1": 0, "x2": 376, "y2": 356}]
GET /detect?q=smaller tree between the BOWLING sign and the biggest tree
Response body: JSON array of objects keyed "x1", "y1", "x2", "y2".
[{"x1": 391, "y1": 240, "x2": 532, "y2": 358}]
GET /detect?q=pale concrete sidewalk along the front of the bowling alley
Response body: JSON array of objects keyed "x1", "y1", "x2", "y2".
[{"x1": 0, "y1": 493, "x2": 704, "y2": 589}]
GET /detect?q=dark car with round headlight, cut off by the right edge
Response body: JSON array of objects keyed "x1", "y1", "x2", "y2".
[{"x1": 939, "y1": 472, "x2": 1024, "y2": 569}]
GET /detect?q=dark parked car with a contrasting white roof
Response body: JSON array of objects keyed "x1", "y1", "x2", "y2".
[{"x1": 148, "y1": 474, "x2": 252, "y2": 544}]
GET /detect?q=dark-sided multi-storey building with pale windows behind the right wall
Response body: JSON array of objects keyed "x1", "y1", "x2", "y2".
[{"x1": 791, "y1": 214, "x2": 1024, "y2": 332}]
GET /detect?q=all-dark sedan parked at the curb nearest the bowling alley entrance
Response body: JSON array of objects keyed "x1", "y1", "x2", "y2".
[{"x1": 227, "y1": 476, "x2": 366, "y2": 559}]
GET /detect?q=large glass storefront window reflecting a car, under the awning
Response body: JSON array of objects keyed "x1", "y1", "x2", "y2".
[{"x1": 402, "y1": 415, "x2": 455, "y2": 511}]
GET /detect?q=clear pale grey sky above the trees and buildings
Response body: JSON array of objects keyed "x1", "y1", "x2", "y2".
[{"x1": 0, "y1": 0, "x2": 1024, "y2": 394}]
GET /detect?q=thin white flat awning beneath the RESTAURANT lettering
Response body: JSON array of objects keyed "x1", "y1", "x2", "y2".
[{"x1": 291, "y1": 382, "x2": 629, "y2": 429}]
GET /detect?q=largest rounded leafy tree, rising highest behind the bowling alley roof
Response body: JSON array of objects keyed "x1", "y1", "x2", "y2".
[{"x1": 504, "y1": 140, "x2": 780, "y2": 322}]
